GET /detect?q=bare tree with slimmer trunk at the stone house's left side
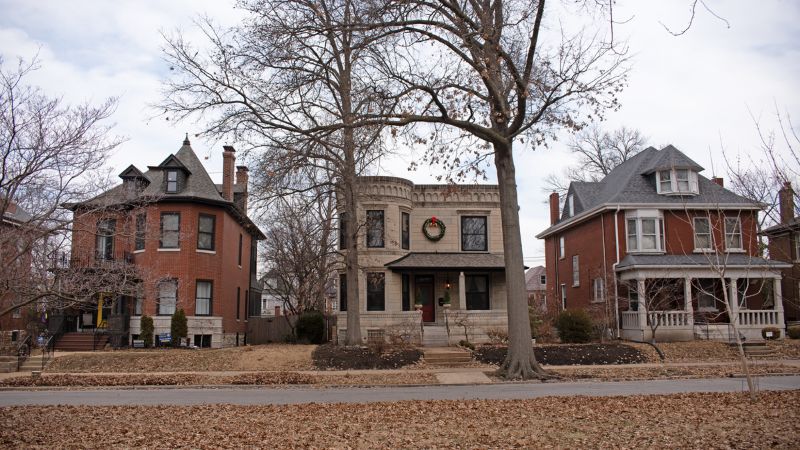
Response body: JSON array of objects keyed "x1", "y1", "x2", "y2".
[{"x1": 161, "y1": 0, "x2": 400, "y2": 345}]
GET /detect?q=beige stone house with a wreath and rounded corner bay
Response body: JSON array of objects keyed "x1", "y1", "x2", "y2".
[{"x1": 338, "y1": 177, "x2": 508, "y2": 346}]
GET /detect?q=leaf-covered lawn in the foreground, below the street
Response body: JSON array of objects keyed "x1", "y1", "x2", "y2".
[{"x1": 0, "y1": 391, "x2": 800, "y2": 448}]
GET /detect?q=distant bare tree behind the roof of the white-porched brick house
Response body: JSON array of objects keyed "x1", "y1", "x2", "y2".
[{"x1": 543, "y1": 124, "x2": 647, "y2": 199}]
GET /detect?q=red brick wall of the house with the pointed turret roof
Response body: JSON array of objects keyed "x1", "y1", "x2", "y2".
[{"x1": 73, "y1": 203, "x2": 252, "y2": 333}]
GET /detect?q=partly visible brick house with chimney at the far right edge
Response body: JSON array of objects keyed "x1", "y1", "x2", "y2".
[{"x1": 761, "y1": 182, "x2": 800, "y2": 323}]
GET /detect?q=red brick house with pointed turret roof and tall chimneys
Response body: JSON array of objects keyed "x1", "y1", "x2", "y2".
[{"x1": 60, "y1": 138, "x2": 264, "y2": 347}]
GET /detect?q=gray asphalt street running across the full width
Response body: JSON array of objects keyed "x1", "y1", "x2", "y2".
[{"x1": 0, "y1": 376, "x2": 800, "y2": 406}]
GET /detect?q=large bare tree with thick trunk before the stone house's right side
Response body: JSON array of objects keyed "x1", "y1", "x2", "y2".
[{"x1": 368, "y1": 0, "x2": 625, "y2": 379}]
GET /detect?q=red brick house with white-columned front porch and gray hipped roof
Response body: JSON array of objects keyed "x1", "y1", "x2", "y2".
[{"x1": 537, "y1": 145, "x2": 786, "y2": 340}]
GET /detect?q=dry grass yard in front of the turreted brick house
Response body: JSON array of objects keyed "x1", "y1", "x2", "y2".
[{"x1": 47, "y1": 344, "x2": 316, "y2": 373}]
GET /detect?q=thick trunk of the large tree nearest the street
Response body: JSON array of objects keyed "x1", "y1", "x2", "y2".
[{"x1": 494, "y1": 144, "x2": 544, "y2": 380}]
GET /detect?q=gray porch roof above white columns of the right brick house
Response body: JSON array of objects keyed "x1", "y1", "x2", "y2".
[{"x1": 617, "y1": 253, "x2": 792, "y2": 272}]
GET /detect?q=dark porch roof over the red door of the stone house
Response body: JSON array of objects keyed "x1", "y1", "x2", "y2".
[{"x1": 384, "y1": 252, "x2": 505, "y2": 272}]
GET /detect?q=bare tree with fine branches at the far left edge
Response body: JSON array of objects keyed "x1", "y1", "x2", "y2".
[{"x1": 0, "y1": 58, "x2": 141, "y2": 324}]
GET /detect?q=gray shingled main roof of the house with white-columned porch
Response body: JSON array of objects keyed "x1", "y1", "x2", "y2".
[{"x1": 539, "y1": 145, "x2": 757, "y2": 236}]
